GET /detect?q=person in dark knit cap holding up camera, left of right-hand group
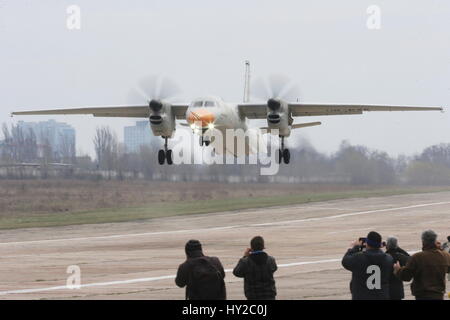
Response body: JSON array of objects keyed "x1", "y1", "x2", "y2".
[{"x1": 342, "y1": 231, "x2": 394, "y2": 300}]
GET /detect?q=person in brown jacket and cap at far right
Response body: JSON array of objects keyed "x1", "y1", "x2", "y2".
[{"x1": 394, "y1": 230, "x2": 450, "y2": 300}]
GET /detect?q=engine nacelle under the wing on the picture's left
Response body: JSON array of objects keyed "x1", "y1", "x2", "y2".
[{"x1": 149, "y1": 100, "x2": 175, "y2": 137}]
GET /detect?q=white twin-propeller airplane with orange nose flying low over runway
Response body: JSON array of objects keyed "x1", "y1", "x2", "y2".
[{"x1": 12, "y1": 62, "x2": 443, "y2": 165}]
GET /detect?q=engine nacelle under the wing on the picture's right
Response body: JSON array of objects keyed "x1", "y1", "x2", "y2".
[{"x1": 267, "y1": 99, "x2": 292, "y2": 137}]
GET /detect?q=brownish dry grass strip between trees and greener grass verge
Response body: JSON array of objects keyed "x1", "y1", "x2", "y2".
[{"x1": 0, "y1": 180, "x2": 394, "y2": 217}]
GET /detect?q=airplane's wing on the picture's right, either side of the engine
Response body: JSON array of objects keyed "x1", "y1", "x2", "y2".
[{"x1": 238, "y1": 103, "x2": 443, "y2": 119}]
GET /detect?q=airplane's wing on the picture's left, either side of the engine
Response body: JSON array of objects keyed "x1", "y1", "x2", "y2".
[{"x1": 12, "y1": 104, "x2": 188, "y2": 119}]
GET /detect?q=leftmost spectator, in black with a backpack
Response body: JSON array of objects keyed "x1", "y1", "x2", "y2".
[{"x1": 175, "y1": 240, "x2": 226, "y2": 300}]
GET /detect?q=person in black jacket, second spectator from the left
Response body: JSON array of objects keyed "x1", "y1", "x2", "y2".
[{"x1": 233, "y1": 236, "x2": 277, "y2": 300}]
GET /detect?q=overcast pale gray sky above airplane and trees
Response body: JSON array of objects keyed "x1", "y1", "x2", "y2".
[{"x1": 0, "y1": 0, "x2": 450, "y2": 155}]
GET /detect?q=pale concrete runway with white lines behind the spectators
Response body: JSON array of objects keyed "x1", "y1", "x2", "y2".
[{"x1": 0, "y1": 192, "x2": 450, "y2": 299}]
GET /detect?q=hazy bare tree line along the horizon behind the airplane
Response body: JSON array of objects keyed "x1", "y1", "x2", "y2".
[{"x1": 0, "y1": 121, "x2": 450, "y2": 185}]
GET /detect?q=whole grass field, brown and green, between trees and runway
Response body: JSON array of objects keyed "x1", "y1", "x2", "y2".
[{"x1": 0, "y1": 180, "x2": 450, "y2": 229}]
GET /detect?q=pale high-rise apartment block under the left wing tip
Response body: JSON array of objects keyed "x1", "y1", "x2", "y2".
[{"x1": 17, "y1": 120, "x2": 76, "y2": 159}]
